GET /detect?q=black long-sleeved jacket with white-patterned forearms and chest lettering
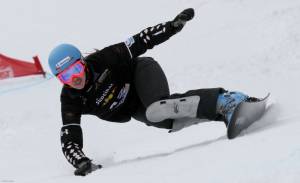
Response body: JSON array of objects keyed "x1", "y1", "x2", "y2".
[{"x1": 61, "y1": 22, "x2": 176, "y2": 167}]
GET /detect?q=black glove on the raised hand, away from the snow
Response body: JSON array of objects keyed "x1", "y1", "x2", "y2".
[{"x1": 171, "y1": 8, "x2": 195, "y2": 32}]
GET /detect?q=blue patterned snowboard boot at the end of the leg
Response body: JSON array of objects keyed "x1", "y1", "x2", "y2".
[{"x1": 217, "y1": 92, "x2": 250, "y2": 126}]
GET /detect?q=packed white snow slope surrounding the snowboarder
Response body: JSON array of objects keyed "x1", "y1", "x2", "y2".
[{"x1": 0, "y1": 0, "x2": 300, "y2": 183}]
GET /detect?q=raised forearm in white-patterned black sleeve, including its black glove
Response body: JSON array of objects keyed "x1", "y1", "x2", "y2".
[{"x1": 125, "y1": 8, "x2": 194, "y2": 58}]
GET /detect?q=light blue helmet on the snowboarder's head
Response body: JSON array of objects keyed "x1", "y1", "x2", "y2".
[{"x1": 48, "y1": 44, "x2": 82, "y2": 75}]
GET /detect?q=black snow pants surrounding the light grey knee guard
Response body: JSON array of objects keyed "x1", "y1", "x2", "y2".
[{"x1": 133, "y1": 57, "x2": 224, "y2": 129}]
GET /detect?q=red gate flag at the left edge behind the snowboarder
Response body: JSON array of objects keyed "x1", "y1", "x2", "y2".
[{"x1": 0, "y1": 53, "x2": 45, "y2": 80}]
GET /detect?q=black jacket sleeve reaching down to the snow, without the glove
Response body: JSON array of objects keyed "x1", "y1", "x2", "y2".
[{"x1": 60, "y1": 88, "x2": 89, "y2": 168}]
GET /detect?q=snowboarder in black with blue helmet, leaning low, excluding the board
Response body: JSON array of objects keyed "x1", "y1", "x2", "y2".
[{"x1": 48, "y1": 8, "x2": 248, "y2": 175}]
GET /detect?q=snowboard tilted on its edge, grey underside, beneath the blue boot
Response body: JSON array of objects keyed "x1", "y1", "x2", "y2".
[{"x1": 227, "y1": 93, "x2": 270, "y2": 139}]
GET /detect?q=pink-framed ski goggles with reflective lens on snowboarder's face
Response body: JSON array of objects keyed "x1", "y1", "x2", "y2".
[{"x1": 57, "y1": 60, "x2": 85, "y2": 84}]
